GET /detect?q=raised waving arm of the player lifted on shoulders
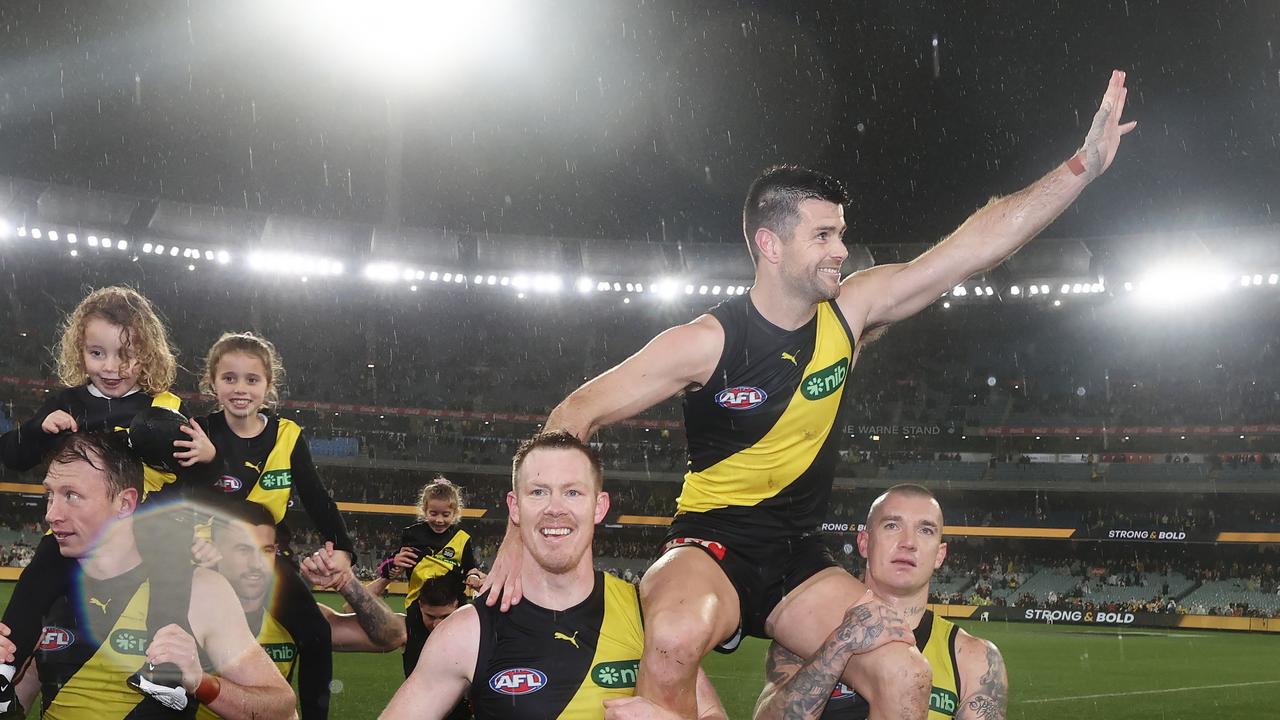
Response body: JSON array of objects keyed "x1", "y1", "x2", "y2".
[{"x1": 838, "y1": 70, "x2": 1137, "y2": 328}]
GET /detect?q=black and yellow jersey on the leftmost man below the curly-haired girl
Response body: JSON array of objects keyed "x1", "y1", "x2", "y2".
[{"x1": 36, "y1": 565, "x2": 196, "y2": 720}]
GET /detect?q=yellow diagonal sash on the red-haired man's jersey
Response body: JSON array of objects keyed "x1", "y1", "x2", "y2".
[{"x1": 559, "y1": 573, "x2": 644, "y2": 720}]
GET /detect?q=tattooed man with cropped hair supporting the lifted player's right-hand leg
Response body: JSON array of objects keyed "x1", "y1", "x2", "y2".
[{"x1": 755, "y1": 484, "x2": 1009, "y2": 720}]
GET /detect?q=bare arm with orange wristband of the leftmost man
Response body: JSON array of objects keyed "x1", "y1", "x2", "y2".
[{"x1": 186, "y1": 568, "x2": 294, "y2": 720}]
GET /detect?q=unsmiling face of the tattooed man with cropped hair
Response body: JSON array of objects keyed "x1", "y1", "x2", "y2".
[{"x1": 858, "y1": 491, "x2": 947, "y2": 594}]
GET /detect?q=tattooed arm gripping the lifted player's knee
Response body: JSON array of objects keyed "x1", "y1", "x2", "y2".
[{"x1": 754, "y1": 602, "x2": 910, "y2": 720}]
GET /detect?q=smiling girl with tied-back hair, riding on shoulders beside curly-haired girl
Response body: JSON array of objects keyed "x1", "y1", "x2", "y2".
[{"x1": 198, "y1": 333, "x2": 355, "y2": 720}]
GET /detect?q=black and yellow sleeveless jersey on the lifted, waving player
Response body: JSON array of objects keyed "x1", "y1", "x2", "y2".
[{"x1": 676, "y1": 295, "x2": 855, "y2": 539}]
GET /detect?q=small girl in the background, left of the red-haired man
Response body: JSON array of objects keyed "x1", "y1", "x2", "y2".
[{"x1": 378, "y1": 478, "x2": 484, "y2": 678}]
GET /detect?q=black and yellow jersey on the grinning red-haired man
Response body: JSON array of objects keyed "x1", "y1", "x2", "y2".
[{"x1": 468, "y1": 571, "x2": 644, "y2": 720}]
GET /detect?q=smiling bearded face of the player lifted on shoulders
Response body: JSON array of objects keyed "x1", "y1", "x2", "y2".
[{"x1": 778, "y1": 199, "x2": 849, "y2": 302}]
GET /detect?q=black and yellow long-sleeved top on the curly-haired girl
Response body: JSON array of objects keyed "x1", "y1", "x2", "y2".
[{"x1": 0, "y1": 384, "x2": 191, "y2": 492}]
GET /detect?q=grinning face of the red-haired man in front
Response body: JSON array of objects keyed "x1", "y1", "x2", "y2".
[{"x1": 507, "y1": 447, "x2": 609, "y2": 574}]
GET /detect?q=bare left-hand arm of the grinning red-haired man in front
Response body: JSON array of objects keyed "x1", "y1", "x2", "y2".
[{"x1": 380, "y1": 605, "x2": 480, "y2": 720}]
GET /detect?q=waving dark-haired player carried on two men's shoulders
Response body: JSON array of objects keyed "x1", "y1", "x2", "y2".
[{"x1": 486, "y1": 70, "x2": 1135, "y2": 720}]
